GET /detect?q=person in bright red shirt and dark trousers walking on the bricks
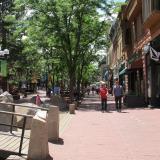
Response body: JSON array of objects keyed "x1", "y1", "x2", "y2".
[{"x1": 99, "y1": 84, "x2": 108, "y2": 112}]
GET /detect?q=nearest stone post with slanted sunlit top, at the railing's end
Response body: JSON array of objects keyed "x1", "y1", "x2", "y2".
[{"x1": 27, "y1": 111, "x2": 50, "y2": 160}]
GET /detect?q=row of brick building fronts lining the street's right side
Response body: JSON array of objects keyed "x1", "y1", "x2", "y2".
[{"x1": 111, "y1": 0, "x2": 160, "y2": 106}]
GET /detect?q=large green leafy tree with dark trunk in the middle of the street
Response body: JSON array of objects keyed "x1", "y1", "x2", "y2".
[{"x1": 17, "y1": 0, "x2": 112, "y2": 98}]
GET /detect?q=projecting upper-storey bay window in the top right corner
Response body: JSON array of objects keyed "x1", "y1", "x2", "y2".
[{"x1": 142, "y1": 0, "x2": 160, "y2": 21}]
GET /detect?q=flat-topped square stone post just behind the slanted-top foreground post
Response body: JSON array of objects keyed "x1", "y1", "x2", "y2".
[{"x1": 48, "y1": 105, "x2": 59, "y2": 141}]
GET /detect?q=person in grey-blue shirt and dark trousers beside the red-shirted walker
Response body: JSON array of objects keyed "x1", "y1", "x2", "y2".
[{"x1": 113, "y1": 80, "x2": 123, "y2": 112}]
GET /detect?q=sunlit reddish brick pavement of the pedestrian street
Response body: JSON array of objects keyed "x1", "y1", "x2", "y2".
[{"x1": 49, "y1": 95, "x2": 160, "y2": 160}]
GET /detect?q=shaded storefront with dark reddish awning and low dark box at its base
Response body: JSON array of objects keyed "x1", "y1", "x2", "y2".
[{"x1": 124, "y1": 52, "x2": 146, "y2": 107}]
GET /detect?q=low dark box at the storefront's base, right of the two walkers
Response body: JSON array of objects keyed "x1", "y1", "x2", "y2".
[{"x1": 124, "y1": 95, "x2": 146, "y2": 107}]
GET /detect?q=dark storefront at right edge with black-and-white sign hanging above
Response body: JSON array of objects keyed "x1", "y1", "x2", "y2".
[{"x1": 146, "y1": 36, "x2": 160, "y2": 106}]
